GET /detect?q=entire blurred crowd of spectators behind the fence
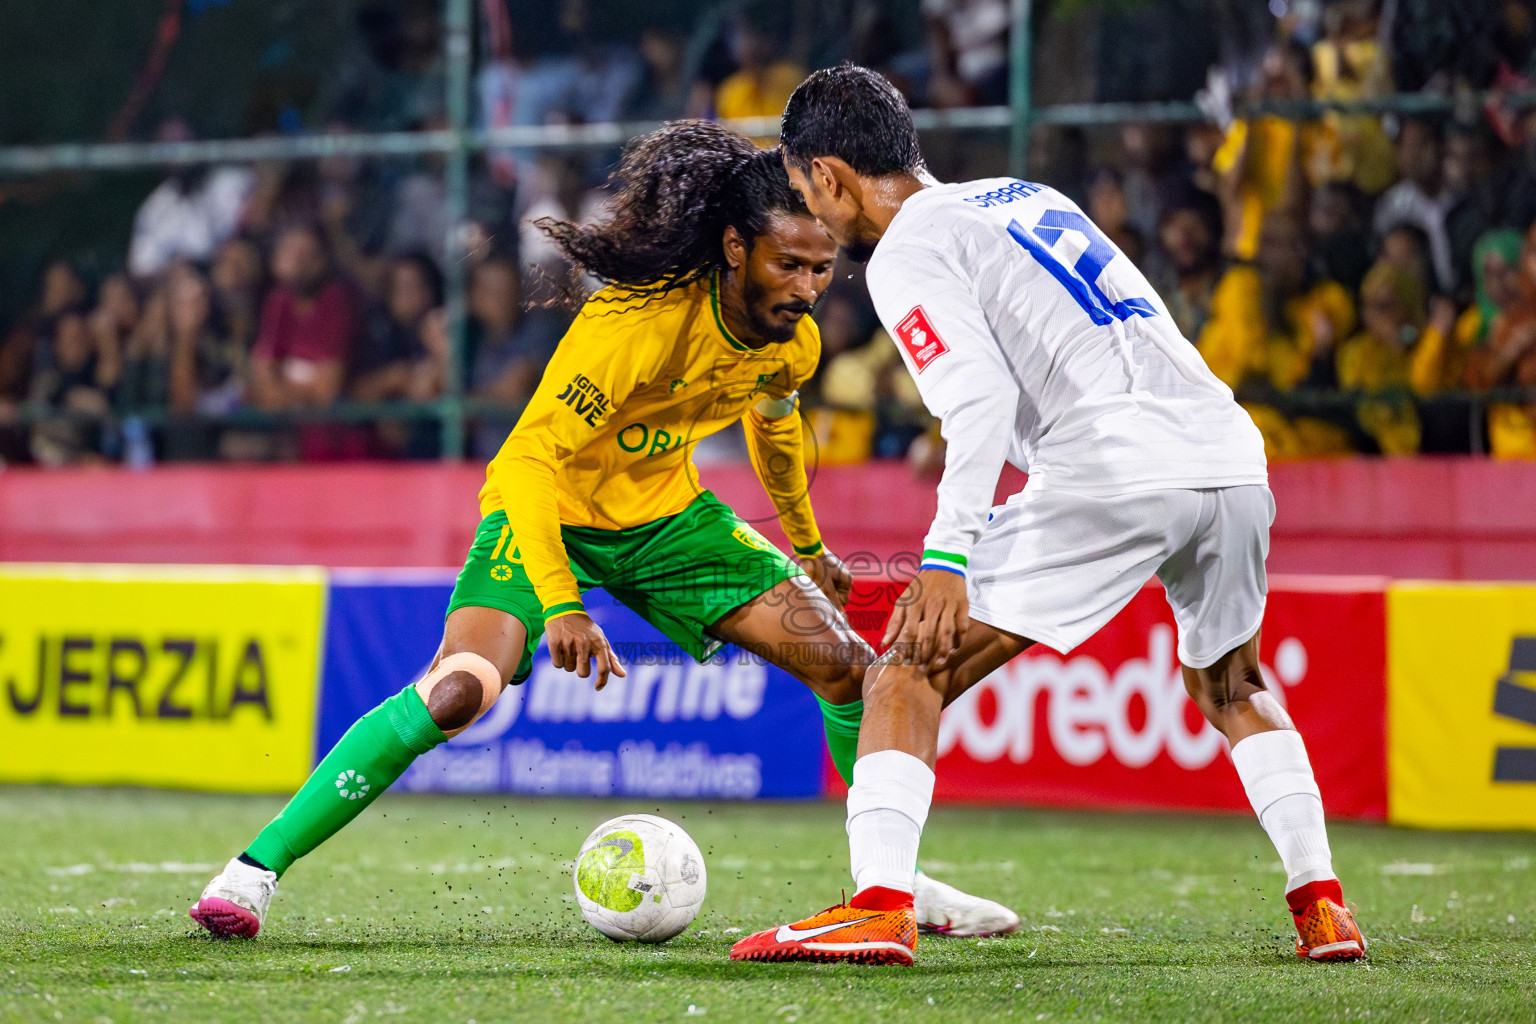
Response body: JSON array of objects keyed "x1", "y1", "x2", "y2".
[{"x1": 0, "y1": 0, "x2": 1536, "y2": 465}]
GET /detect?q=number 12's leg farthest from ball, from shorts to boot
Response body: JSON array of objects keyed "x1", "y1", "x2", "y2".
[{"x1": 1158, "y1": 487, "x2": 1366, "y2": 960}]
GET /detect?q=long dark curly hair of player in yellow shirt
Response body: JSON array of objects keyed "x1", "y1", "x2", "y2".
[{"x1": 535, "y1": 121, "x2": 809, "y2": 299}]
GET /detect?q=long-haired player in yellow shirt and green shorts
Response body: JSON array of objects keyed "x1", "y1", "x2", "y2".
[{"x1": 192, "y1": 121, "x2": 1018, "y2": 936}]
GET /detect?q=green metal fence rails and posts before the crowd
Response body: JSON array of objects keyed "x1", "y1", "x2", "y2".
[{"x1": 0, "y1": 0, "x2": 1536, "y2": 459}]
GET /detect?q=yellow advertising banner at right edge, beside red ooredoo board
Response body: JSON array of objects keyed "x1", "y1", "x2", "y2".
[{"x1": 1387, "y1": 583, "x2": 1536, "y2": 829}]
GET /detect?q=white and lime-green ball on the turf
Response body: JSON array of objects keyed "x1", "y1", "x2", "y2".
[{"x1": 576, "y1": 814, "x2": 705, "y2": 943}]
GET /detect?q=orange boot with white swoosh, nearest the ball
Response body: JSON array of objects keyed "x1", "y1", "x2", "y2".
[{"x1": 731, "y1": 887, "x2": 917, "y2": 967}]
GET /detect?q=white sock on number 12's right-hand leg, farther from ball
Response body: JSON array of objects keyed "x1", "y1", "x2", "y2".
[{"x1": 1232, "y1": 729, "x2": 1338, "y2": 892}]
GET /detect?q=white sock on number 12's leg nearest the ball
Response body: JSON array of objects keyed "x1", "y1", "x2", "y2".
[{"x1": 848, "y1": 751, "x2": 934, "y2": 892}]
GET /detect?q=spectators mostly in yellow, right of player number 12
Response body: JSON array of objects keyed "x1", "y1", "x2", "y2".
[{"x1": 1084, "y1": 0, "x2": 1536, "y2": 457}]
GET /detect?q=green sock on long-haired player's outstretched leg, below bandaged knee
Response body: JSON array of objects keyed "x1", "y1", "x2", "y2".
[{"x1": 246, "y1": 686, "x2": 445, "y2": 877}]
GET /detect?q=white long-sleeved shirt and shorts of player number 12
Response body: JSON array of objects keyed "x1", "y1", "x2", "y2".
[{"x1": 868, "y1": 178, "x2": 1273, "y2": 668}]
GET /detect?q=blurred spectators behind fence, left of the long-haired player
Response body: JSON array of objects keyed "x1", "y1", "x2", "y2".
[{"x1": 0, "y1": 160, "x2": 567, "y2": 465}]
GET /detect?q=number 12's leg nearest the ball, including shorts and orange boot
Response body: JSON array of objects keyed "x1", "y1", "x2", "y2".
[{"x1": 731, "y1": 488, "x2": 1197, "y2": 963}]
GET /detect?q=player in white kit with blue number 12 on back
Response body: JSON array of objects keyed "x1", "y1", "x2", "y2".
[{"x1": 731, "y1": 64, "x2": 1366, "y2": 964}]
